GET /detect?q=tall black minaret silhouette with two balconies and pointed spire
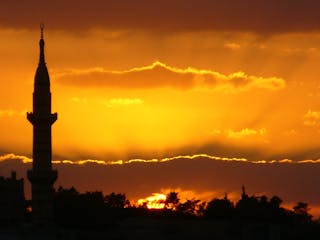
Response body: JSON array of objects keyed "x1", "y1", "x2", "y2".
[{"x1": 27, "y1": 25, "x2": 58, "y2": 226}]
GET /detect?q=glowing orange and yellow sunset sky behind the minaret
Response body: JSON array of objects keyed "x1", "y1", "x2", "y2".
[{"x1": 0, "y1": 0, "x2": 320, "y2": 214}]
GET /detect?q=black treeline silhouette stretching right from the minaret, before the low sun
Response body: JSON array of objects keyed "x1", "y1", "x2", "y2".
[{"x1": 50, "y1": 187, "x2": 319, "y2": 231}]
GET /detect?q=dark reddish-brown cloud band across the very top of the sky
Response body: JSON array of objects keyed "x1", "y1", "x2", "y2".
[{"x1": 0, "y1": 0, "x2": 320, "y2": 33}]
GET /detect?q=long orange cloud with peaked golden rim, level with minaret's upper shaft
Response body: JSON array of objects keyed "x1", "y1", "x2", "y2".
[{"x1": 57, "y1": 62, "x2": 286, "y2": 92}]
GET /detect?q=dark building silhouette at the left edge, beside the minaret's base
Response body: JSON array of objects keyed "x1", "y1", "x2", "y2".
[{"x1": 0, "y1": 172, "x2": 25, "y2": 225}]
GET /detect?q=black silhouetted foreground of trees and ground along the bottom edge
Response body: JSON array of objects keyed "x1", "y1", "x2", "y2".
[{"x1": 0, "y1": 187, "x2": 320, "y2": 240}]
